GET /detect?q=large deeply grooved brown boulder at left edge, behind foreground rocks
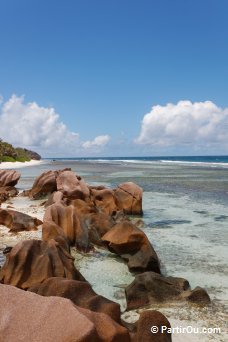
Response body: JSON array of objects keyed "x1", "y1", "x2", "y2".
[{"x1": 0, "y1": 240, "x2": 84, "y2": 289}]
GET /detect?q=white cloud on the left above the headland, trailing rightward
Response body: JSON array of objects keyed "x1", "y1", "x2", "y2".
[{"x1": 0, "y1": 95, "x2": 110, "y2": 156}]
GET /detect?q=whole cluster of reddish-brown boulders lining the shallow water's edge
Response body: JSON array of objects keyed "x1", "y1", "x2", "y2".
[{"x1": 0, "y1": 169, "x2": 214, "y2": 341}]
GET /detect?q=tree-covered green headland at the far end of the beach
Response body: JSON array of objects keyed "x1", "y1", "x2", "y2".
[{"x1": 0, "y1": 138, "x2": 41, "y2": 163}]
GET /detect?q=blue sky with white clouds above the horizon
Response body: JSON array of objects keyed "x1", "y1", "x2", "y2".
[{"x1": 0, "y1": 0, "x2": 228, "y2": 157}]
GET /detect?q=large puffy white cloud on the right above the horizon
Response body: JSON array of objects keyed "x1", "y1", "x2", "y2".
[{"x1": 135, "y1": 101, "x2": 228, "y2": 148}]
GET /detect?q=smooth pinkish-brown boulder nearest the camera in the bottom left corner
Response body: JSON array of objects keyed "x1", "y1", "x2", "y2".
[{"x1": 0, "y1": 285, "x2": 130, "y2": 342}]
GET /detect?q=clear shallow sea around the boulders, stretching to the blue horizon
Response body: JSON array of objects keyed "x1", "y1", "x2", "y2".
[{"x1": 0, "y1": 156, "x2": 228, "y2": 341}]
